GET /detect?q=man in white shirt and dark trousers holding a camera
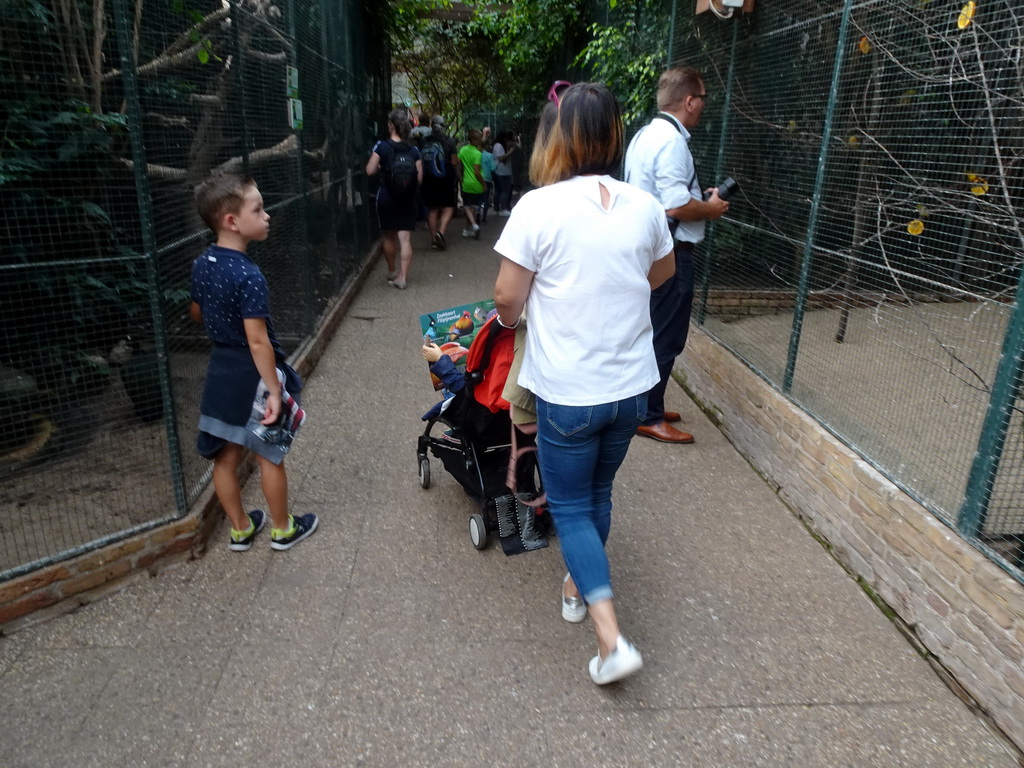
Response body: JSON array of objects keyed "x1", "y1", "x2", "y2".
[{"x1": 626, "y1": 67, "x2": 729, "y2": 443}]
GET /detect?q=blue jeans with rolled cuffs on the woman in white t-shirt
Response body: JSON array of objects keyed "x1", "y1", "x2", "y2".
[{"x1": 537, "y1": 392, "x2": 647, "y2": 605}]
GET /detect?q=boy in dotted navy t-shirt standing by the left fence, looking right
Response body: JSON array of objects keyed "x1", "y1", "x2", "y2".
[{"x1": 189, "y1": 173, "x2": 319, "y2": 552}]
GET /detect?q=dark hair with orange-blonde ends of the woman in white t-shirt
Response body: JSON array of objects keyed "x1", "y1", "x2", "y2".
[{"x1": 529, "y1": 83, "x2": 623, "y2": 186}]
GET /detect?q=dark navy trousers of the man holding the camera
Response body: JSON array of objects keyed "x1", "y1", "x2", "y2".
[{"x1": 643, "y1": 240, "x2": 693, "y2": 426}]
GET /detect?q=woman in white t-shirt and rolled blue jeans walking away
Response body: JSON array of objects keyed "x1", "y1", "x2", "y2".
[{"x1": 495, "y1": 83, "x2": 675, "y2": 685}]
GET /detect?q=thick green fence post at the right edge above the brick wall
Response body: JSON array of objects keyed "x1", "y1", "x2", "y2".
[{"x1": 956, "y1": 288, "x2": 1024, "y2": 538}]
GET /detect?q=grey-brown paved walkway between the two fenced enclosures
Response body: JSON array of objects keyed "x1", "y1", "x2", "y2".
[{"x1": 0, "y1": 219, "x2": 1018, "y2": 768}]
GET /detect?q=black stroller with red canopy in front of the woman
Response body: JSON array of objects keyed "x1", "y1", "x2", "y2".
[{"x1": 416, "y1": 317, "x2": 551, "y2": 555}]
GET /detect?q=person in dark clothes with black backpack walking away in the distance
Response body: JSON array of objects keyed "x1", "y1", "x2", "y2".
[{"x1": 367, "y1": 110, "x2": 423, "y2": 290}]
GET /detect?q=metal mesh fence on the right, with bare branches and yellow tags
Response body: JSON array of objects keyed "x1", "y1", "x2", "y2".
[{"x1": 672, "y1": 0, "x2": 1024, "y2": 578}]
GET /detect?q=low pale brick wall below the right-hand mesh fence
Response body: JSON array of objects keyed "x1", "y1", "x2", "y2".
[{"x1": 676, "y1": 329, "x2": 1024, "y2": 748}]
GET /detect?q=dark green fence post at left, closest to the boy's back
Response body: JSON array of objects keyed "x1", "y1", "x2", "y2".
[{"x1": 114, "y1": 0, "x2": 188, "y2": 515}]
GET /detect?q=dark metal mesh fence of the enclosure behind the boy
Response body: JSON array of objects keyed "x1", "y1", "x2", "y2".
[{"x1": 0, "y1": 0, "x2": 390, "y2": 581}]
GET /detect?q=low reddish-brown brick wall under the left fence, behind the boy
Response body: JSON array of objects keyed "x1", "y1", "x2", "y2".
[{"x1": 0, "y1": 252, "x2": 379, "y2": 635}]
